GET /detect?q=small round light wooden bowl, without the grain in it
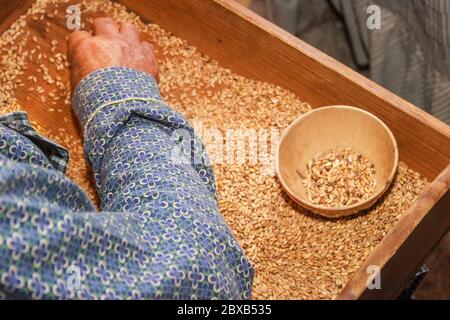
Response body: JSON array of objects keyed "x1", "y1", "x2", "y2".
[{"x1": 276, "y1": 106, "x2": 398, "y2": 218}]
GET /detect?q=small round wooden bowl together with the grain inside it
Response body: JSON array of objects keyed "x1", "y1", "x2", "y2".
[{"x1": 275, "y1": 105, "x2": 398, "y2": 218}]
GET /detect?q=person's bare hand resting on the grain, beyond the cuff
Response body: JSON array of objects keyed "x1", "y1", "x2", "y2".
[{"x1": 67, "y1": 18, "x2": 158, "y2": 90}]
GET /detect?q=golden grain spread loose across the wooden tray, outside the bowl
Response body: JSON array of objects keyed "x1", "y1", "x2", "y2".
[{"x1": 0, "y1": 0, "x2": 426, "y2": 299}]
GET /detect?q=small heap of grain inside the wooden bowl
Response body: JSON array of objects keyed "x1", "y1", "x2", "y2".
[{"x1": 297, "y1": 148, "x2": 376, "y2": 208}]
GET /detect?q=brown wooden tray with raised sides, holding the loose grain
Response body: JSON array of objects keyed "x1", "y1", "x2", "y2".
[{"x1": 0, "y1": 0, "x2": 450, "y2": 299}]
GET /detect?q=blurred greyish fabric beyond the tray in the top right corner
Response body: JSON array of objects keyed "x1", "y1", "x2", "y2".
[{"x1": 265, "y1": 0, "x2": 450, "y2": 124}]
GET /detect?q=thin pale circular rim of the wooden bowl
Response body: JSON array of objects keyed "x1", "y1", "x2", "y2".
[{"x1": 275, "y1": 105, "x2": 398, "y2": 218}]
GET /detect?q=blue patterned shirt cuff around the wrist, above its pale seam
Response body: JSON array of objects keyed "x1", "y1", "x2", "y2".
[{"x1": 72, "y1": 67, "x2": 162, "y2": 131}]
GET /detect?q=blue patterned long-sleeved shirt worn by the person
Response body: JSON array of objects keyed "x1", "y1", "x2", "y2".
[{"x1": 0, "y1": 67, "x2": 253, "y2": 299}]
